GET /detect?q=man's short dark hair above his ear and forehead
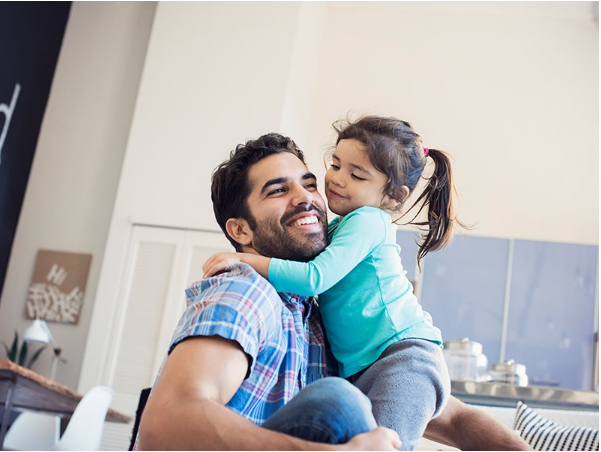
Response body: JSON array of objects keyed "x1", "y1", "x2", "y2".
[{"x1": 211, "y1": 133, "x2": 305, "y2": 251}]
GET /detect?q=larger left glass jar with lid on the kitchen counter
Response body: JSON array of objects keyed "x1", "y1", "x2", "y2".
[{"x1": 442, "y1": 337, "x2": 488, "y2": 381}]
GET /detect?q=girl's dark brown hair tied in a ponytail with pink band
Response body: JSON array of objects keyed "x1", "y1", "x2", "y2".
[{"x1": 333, "y1": 116, "x2": 464, "y2": 264}]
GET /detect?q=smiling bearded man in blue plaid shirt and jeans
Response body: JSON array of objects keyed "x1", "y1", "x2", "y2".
[{"x1": 138, "y1": 134, "x2": 528, "y2": 450}]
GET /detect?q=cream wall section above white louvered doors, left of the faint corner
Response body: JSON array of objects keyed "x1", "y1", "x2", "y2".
[{"x1": 121, "y1": 2, "x2": 310, "y2": 229}]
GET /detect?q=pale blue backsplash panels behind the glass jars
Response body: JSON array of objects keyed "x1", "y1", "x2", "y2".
[{"x1": 397, "y1": 231, "x2": 599, "y2": 390}]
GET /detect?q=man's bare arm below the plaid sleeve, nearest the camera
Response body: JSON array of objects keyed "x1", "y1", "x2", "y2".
[{"x1": 139, "y1": 336, "x2": 394, "y2": 450}]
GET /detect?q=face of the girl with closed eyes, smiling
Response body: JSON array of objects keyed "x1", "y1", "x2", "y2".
[{"x1": 325, "y1": 138, "x2": 393, "y2": 216}]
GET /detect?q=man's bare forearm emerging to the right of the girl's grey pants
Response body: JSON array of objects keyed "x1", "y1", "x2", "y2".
[{"x1": 424, "y1": 396, "x2": 533, "y2": 450}]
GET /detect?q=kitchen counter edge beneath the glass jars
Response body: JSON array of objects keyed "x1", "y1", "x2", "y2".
[{"x1": 451, "y1": 381, "x2": 599, "y2": 412}]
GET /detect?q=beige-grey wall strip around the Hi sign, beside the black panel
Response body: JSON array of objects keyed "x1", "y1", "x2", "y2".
[{"x1": 0, "y1": 2, "x2": 156, "y2": 387}]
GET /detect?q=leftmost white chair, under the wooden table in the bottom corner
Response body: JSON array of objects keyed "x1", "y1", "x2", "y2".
[{"x1": 4, "y1": 411, "x2": 60, "y2": 450}]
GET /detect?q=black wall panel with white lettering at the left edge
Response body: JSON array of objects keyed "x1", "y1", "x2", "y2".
[{"x1": 0, "y1": 2, "x2": 71, "y2": 300}]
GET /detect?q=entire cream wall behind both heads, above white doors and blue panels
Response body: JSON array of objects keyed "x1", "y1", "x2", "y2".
[{"x1": 86, "y1": 2, "x2": 599, "y2": 244}]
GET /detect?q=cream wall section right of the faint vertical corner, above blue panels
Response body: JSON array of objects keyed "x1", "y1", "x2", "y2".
[{"x1": 305, "y1": 2, "x2": 599, "y2": 244}]
